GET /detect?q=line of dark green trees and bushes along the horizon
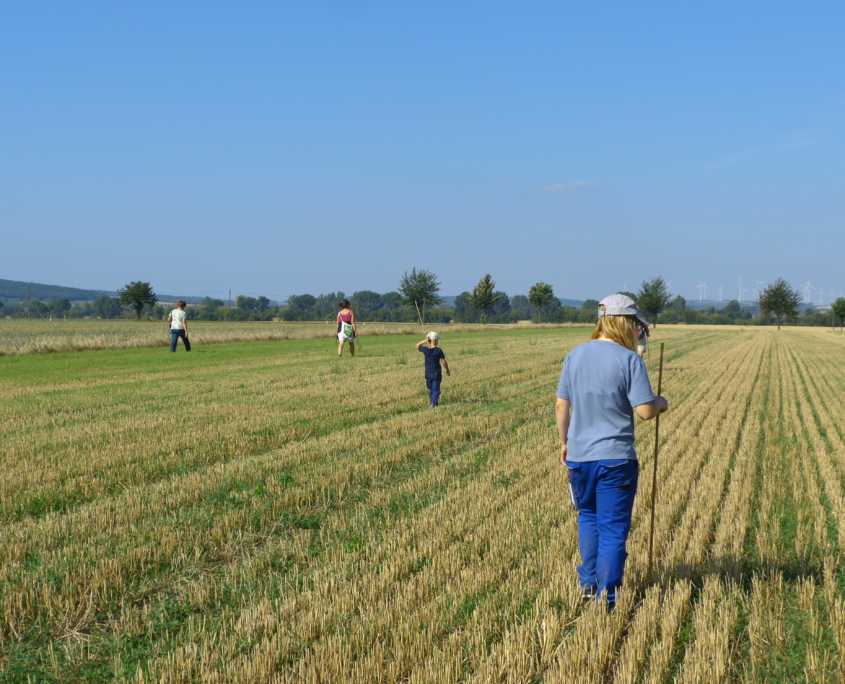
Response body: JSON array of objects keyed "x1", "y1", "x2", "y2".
[{"x1": 0, "y1": 268, "x2": 845, "y2": 327}]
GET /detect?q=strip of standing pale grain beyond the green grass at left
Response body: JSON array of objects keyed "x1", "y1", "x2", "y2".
[{"x1": 0, "y1": 319, "x2": 571, "y2": 356}]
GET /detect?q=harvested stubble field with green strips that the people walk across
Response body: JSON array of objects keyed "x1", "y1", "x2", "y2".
[{"x1": 0, "y1": 327, "x2": 845, "y2": 683}]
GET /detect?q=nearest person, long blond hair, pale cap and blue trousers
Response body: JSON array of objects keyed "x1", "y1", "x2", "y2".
[{"x1": 555, "y1": 294, "x2": 669, "y2": 610}]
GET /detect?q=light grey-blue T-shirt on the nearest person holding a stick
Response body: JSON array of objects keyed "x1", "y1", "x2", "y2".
[{"x1": 557, "y1": 340, "x2": 654, "y2": 463}]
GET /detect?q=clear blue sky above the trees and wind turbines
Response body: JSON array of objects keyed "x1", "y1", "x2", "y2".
[{"x1": 0, "y1": 0, "x2": 845, "y2": 299}]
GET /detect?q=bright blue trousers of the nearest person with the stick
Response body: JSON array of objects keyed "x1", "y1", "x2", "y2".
[{"x1": 566, "y1": 459, "x2": 640, "y2": 605}]
